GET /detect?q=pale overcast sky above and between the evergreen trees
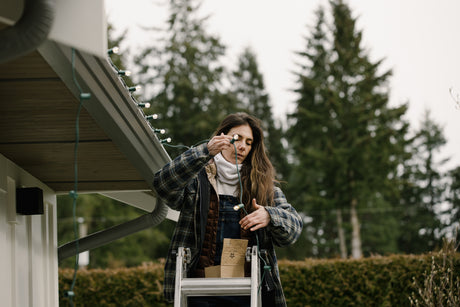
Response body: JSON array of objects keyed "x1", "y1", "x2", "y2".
[{"x1": 106, "y1": 0, "x2": 460, "y2": 168}]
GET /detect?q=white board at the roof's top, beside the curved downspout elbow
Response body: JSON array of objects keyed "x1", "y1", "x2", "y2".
[{"x1": 48, "y1": 0, "x2": 108, "y2": 58}]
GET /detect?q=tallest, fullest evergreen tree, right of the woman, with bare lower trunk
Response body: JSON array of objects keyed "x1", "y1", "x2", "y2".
[{"x1": 290, "y1": 0, "x2": 408, "y2": 258}]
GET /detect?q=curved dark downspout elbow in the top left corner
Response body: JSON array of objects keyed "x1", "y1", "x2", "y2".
[{"x1": 0, "y1": 0, "x2": 56, "y2": 64}]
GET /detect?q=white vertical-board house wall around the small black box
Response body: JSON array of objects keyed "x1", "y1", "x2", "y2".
[{"x1": 0, "y1": 155, "x2": 58, "y2": 307}]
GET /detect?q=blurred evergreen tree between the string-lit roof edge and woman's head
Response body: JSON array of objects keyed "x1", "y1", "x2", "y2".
[{"x1": 136, "y1": 0, "x2": 235, "y2": 157}]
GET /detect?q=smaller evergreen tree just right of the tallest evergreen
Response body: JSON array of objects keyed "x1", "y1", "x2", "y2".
[{"x1": 399, "y1": 111, "x2": 447, "y2": 253}]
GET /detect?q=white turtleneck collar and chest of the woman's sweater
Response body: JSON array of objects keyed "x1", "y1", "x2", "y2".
[{"x1": 214, "y1": 153, "x2": 242, "y2": 196}]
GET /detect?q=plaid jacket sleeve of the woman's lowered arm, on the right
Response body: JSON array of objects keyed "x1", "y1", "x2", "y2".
[{"x1": 265, "y1": 187, "x2": 303, "y2": 247}]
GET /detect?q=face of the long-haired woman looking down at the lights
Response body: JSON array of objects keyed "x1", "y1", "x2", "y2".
[{"x1": 222, "y1": 124, "x2": 254, "y2": 164}]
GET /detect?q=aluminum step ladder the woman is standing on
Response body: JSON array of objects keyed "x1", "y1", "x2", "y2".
[{"x1": 174, "y1": 246, "x2": 262, "y2": 307}]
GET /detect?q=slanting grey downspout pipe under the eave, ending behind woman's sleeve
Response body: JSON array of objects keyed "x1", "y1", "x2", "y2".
[{"x1": 58, "y1": 202, "x2": 168, "y2": 261}]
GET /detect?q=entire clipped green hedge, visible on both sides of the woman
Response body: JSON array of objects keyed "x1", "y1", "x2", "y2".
[{"x1": 59, "y1": 253, "x2": 460, "y2": 306}]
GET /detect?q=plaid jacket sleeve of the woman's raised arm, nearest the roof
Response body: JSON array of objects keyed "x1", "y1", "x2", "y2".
[{"x1": 153, "y1": 144, "x2": 211, "y2": 210}]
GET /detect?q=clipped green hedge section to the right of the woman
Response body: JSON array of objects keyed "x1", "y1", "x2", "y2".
[{"x1": 280, "y1": 256, "x2": 431, "y2": 306}]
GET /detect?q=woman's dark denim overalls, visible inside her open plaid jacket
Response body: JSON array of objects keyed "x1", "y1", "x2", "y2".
[{"x1": 188, "y1": 195, "x2": 250, "y2": 307}]
